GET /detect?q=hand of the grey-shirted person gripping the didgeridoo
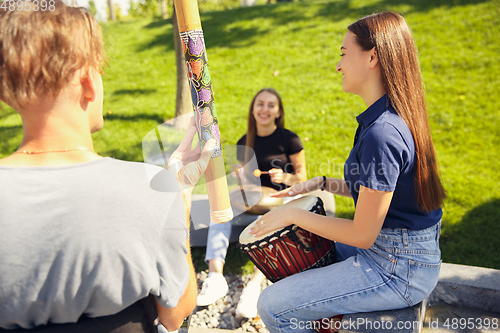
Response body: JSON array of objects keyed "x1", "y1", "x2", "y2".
[{"x1": 167, "y1": 117, "x2": 216, "y2": 190}]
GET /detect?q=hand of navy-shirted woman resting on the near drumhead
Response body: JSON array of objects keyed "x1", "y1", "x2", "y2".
[{"x1": 248, "y1": 207, "x2": 304, "y2": 237}]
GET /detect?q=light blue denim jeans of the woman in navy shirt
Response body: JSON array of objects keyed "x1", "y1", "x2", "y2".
[{"x1": 258, "y1": 222, "x2": 441, "y2": 333}]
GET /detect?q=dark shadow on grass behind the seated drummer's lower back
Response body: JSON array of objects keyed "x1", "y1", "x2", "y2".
[{"x1": 441, "y1": 199, "x2": 500, "y2": 269}]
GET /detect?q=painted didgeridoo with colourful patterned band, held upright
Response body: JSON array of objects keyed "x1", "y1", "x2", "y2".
[{"x1": 175, "y1": 0, "x2": 233, "y2": 223}]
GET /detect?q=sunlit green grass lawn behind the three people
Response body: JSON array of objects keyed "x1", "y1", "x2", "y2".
[{"x1": 0, "y1": 0, "x2": 500, "y2": 271}]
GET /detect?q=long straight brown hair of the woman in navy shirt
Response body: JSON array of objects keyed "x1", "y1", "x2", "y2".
[{"x1": 348, "y1": 12, "x2": 446, "y2": 212}]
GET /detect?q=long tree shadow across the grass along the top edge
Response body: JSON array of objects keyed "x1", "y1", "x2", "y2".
[{"x1": 138, "y1": 0, "x2": 488, "y2": 51}]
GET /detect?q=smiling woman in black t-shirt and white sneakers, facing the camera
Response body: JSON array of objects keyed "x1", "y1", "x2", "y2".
[{"x1": 197, "y1": 88, "x2": 307, "y2": 318}]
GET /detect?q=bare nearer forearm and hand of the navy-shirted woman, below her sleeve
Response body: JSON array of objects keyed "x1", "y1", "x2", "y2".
[{"x1": 250, "y1": 186, "x2": 394, "y2": 249}]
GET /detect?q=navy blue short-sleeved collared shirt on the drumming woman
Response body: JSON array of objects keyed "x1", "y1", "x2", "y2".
[{"x1": 344, "y1": 95, "x2": 443, "y2": 230}]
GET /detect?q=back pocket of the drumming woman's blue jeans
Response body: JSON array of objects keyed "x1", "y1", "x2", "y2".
[{"x1": 405, "y1": 256, "x2": 441, "y2": 306}]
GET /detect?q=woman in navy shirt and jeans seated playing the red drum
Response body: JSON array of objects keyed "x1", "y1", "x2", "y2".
[{"x1": 251, "y1": 12, "x2": 446, "y2": 332}]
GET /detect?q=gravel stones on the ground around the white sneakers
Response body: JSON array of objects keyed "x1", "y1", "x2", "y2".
[{"x1": 191, "y1": 271, "x2": 272, "y2": 333}]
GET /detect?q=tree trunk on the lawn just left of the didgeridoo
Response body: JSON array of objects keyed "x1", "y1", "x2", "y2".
[{"x1": 172, "y1": 5, "x2": 193, "y2": 128}]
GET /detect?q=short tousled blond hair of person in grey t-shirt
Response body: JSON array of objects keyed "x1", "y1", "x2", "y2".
[{"x1": 0, "y1": 0, "x2": 106, "y2": 109}]
